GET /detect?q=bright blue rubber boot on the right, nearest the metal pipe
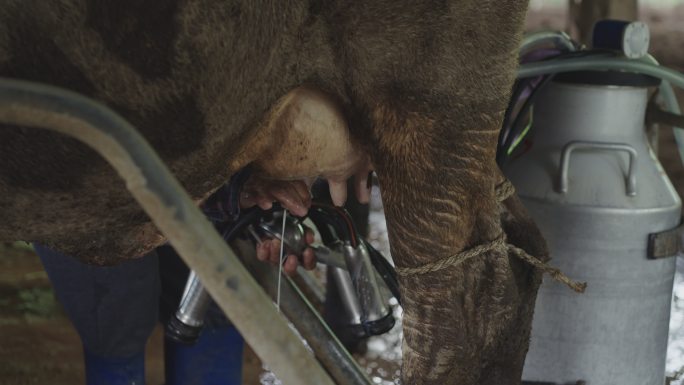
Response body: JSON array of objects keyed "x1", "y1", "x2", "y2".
[{"x1": 164, "y1": 325, "x2": 244, "y2": 385}]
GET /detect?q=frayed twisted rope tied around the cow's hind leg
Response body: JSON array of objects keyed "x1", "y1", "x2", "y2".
[{"x1": 396, "y1": 181, "x2": 587, "y2": 293}]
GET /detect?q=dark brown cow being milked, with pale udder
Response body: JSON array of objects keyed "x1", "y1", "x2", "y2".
[{"x1": 0, "y1": 0, "x2": 548, "y2": 385}]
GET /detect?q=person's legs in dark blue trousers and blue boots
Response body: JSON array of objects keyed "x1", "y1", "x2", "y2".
[{"x1": 34, "y1": 245, "x2": 243, "y2": 385}]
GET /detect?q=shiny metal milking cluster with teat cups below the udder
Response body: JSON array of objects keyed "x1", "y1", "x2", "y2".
[{"x1": 166, "y1": 202, "x2": 400, "y2": 344}]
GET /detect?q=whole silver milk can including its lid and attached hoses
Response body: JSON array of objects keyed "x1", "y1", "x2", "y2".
[{"x1": 497, "y1": 20, "x2": 684, "y2": 385}]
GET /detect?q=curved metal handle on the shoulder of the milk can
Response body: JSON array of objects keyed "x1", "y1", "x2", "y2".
[{"x1": 558, "y1": 141, "x2": 637, "y2": 196}]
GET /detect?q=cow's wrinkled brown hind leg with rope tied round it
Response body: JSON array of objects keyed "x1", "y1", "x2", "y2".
[{"x1": 372, "y1": 90, "x2": 539, "y2": 385}]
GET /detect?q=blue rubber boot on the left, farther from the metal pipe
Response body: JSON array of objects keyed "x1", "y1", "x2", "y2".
[{"x1": 83, "y1": 349, "x2": 145, "y2": 385}]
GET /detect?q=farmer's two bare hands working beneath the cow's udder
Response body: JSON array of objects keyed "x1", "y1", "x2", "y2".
[{"x1": 240, "y1": 175, "x2": 316, "y2": 275}]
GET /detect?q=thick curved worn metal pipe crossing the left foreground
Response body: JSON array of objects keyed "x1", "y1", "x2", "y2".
[{"x1": 0, "y1": 78, "x2": 333, "y2": 385}]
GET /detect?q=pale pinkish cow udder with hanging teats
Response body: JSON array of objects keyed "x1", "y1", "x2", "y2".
[{"x1": 253, "y1": 87, "x2": 372, "y2": 206}]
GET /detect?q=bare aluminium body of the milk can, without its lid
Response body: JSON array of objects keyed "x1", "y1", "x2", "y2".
[{"x1": 504, "y1": 76, "x2": 681, "y2": 385}]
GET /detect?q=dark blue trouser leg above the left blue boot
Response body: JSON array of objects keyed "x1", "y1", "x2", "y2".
[{"x1": 34, "y1": 245, "x2": 161, "y2": 358}]
